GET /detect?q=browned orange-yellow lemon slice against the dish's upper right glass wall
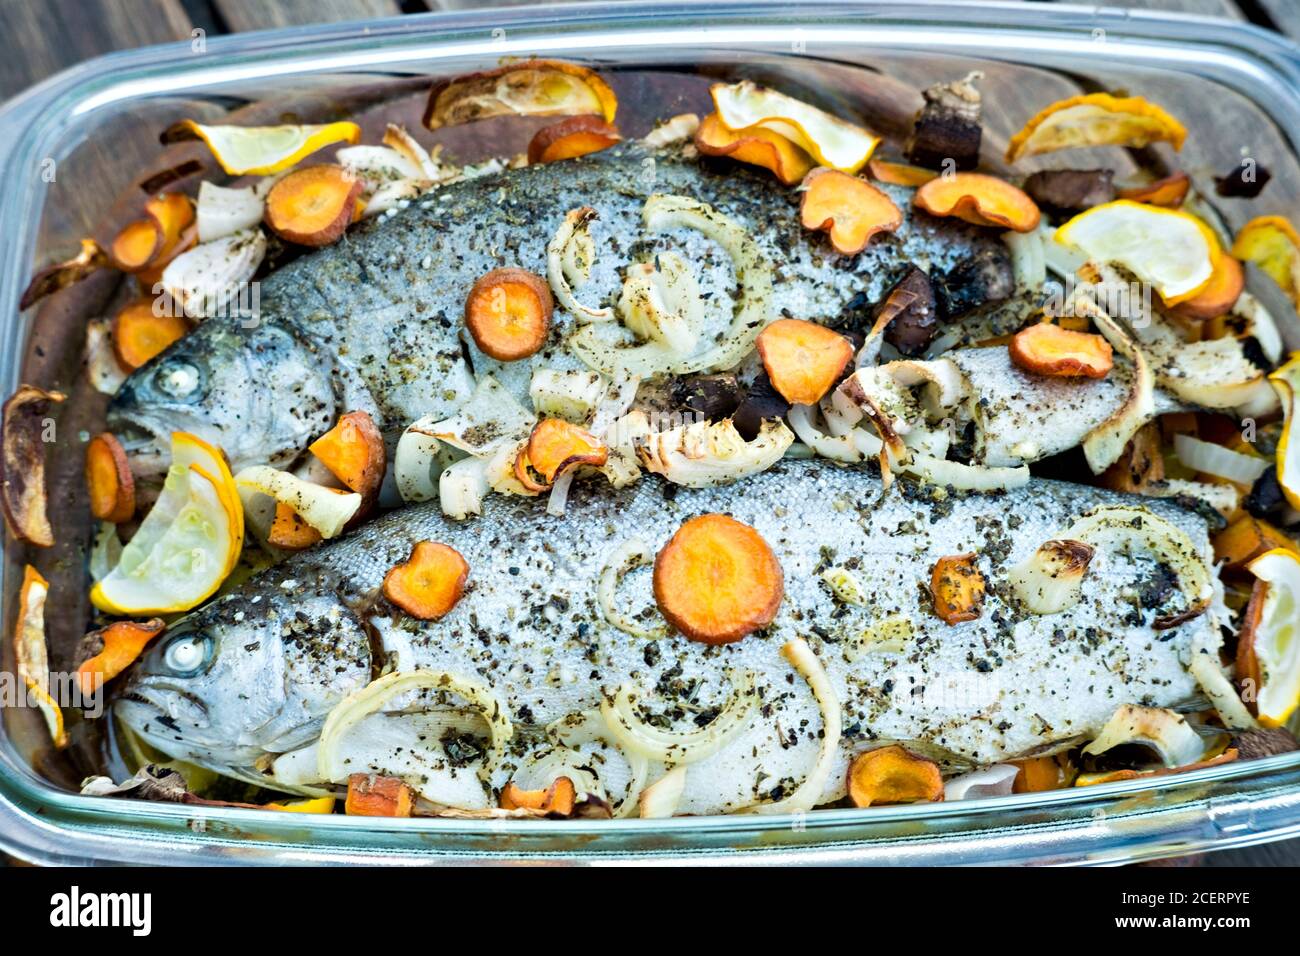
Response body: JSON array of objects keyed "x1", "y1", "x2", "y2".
[{"x1": 1006, "y1": 92, "x2": 1187, "y2": 163}]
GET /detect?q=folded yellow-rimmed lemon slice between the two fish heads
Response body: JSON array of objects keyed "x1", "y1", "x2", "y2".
[{"x1": 90, "y1": 464, "x2": 239, "y2": 614}]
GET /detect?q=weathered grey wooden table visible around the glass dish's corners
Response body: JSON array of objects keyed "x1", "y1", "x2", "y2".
[{"x1": 0, "y1": 0, "x2": 1300, "y2": 866}]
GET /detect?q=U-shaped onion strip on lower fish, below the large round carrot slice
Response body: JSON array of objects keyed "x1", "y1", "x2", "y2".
[{"x1": 601, "y1": 670, "x2": 758, "y2": 763}]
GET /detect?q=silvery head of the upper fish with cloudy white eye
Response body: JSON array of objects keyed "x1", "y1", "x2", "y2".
[{"x1": 107, "y1": 319, "x2": 339, "y2": 480}]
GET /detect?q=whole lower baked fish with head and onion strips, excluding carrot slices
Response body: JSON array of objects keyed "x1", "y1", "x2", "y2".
[{"x1": 116, "y1": 460, "x2": 1231, "y2": 814}]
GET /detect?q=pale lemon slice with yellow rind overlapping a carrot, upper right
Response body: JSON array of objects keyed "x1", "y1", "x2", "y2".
[{"x1": 1056, "y1": 199, "x2": 1223, "y2": 306}]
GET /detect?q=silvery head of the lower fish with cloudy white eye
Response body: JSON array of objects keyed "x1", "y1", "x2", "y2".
[{"x1": 113, "y1": 585, "x2": 371, "y2": 779}]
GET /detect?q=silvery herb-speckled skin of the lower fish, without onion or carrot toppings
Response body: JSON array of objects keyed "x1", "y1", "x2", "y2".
[{"x1": 114, "y1": 460, "x2": 1223, "y2": 813}]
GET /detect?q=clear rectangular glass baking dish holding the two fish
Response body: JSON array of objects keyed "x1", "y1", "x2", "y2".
[{"x1": 0, "y1": 0, "x2": 1300, "y2": 865}]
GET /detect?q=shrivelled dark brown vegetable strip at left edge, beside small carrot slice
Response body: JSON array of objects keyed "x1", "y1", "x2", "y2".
[{"x1": 0, "y1": 385, "x2": 64, "y2": 548}]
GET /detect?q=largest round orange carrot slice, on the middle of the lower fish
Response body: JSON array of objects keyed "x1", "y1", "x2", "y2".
[{"x1": 654, "y1": 514, "x2": 785, "y2": 644}]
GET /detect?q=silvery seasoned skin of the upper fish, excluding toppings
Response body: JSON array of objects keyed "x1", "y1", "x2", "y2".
[{"x1": 108, "y1": 142, "x2": 998, "y2": 473}]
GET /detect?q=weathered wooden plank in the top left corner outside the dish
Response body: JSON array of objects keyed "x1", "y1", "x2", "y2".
[{"x1": 0, "y1": 0, "x2": 191, "y2": 99}]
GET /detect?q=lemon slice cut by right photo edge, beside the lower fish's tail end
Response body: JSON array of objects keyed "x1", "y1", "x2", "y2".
[{"x1": 1247, "y1": 548, "x2": 1300, "y2": 727}]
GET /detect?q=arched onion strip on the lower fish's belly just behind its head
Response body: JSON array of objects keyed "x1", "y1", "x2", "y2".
[{"x1": 317, "y1": 670, "x2": 515, "y2": 782}]
